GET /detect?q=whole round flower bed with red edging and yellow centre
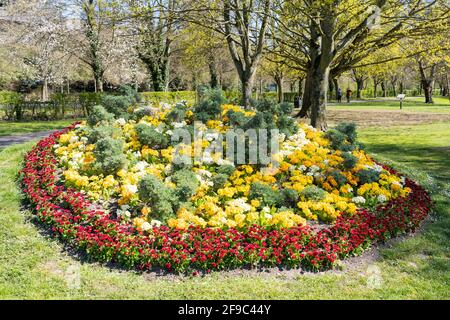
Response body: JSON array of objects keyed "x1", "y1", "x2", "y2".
[{"x1": 21, "y1": 99, "x2": 431, "y2": 271}]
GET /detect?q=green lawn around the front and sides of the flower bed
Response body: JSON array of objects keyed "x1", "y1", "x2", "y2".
[{"x1": 0, "y1": 123, "x2": 450, "y2": 299}]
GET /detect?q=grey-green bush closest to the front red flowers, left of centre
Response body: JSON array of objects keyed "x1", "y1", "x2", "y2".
[{"x1": 138, "y1": 174, "x2": 175, "y2": 222}]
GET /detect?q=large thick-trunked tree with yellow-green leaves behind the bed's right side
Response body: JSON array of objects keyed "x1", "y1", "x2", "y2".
[{"x1": 277, "y1": 0, "x2": 449, "y2": 129}]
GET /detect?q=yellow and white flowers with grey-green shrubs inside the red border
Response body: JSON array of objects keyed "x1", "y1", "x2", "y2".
[{"x1": 53, "y1": 104, "x2": 410, "y2": 231}]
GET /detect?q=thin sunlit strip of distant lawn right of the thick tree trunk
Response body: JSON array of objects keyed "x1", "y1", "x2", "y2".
[{"x1": 328, "y1": 97, "x2": 450, "y2": 114}]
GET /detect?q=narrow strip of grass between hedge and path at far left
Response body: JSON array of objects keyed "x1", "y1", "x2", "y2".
[{"x1": 0, "y1": 119, "x2": 76, "y2": 137}]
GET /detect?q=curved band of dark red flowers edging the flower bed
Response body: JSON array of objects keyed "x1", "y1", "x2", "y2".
[{"x1": 20, "y1": 124, "x2": 432, "y2": 272}]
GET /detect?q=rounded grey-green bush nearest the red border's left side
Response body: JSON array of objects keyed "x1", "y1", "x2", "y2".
[{"x1": 94, "y1": 137, "x2": 126, "y2": 175}]
